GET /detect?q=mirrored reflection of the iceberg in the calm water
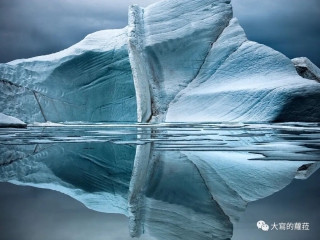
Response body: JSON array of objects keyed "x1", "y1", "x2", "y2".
[{"x1": 0, "y1": 125, "x2": 319, "y2": 239}]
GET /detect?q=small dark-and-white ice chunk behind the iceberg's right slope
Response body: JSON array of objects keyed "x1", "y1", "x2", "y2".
[{"x1": 291, "y1": 57, "x2": 320, "y2": 82}]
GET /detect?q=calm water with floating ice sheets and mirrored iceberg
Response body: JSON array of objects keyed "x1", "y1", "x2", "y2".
[{"x1": 0, "y1": 123, "x2": 320, "y2": 240}]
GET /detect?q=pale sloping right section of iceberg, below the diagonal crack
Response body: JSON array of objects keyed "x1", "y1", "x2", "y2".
[{"x1": 166, "y1": 19, "x2": 320, "y2": 121}]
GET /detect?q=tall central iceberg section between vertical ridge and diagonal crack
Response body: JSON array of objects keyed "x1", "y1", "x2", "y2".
[{"x1": 129, "y1": 0, "x2": 232, "y2": 122}]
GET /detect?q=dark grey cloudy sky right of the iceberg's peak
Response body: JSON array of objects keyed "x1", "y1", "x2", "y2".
[{"x1": 232, "y1": 0, "x2": 320, "y2": 66}]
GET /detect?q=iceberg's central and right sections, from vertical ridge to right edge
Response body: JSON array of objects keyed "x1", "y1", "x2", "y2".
[{"x1": 129, "y1": 0, "x2": 320, "y2": 122}]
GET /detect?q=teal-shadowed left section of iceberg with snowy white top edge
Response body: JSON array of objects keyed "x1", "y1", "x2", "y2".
[{"x1": 0, "y1": 28, "x2": 136, "y2": 122}]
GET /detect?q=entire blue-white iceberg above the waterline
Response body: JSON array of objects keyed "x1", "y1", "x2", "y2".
[{"x1": 0, "y1": 0, "x2": 320, "y2": 123}]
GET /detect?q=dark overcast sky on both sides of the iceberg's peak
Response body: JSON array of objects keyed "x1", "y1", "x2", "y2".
[{"x1": 0, "y1": 0, "x2": 320, "y2": 66}]
